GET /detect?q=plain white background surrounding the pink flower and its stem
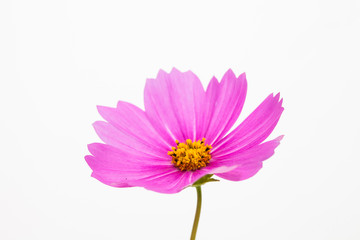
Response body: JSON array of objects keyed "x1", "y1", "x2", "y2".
[{"x1": 0, "y1": 0, "x2": 360, "y2": 240}]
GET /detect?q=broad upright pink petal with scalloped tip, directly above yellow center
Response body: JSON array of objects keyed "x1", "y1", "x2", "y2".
[{"x1": 144, "y1": 68, "x2": 205, "y2": 145}]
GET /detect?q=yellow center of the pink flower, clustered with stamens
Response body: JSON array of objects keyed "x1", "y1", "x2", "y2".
[{"x1": 168, "y1": 138, "x2": 212, "y2": 171}]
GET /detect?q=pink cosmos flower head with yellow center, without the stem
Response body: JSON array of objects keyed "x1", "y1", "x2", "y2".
[{"x1": 85, "y1": 68, "x2": 284, "y2": 193}]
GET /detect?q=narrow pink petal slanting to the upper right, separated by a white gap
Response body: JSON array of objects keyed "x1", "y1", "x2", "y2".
[{"x1": 212, "y1": 94, "x2": 284, "y2": 158}]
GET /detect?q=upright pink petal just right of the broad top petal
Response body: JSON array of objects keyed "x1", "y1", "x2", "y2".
[{"x1": 204, "y1": 69, "x2": 247, "y2": 145}]
